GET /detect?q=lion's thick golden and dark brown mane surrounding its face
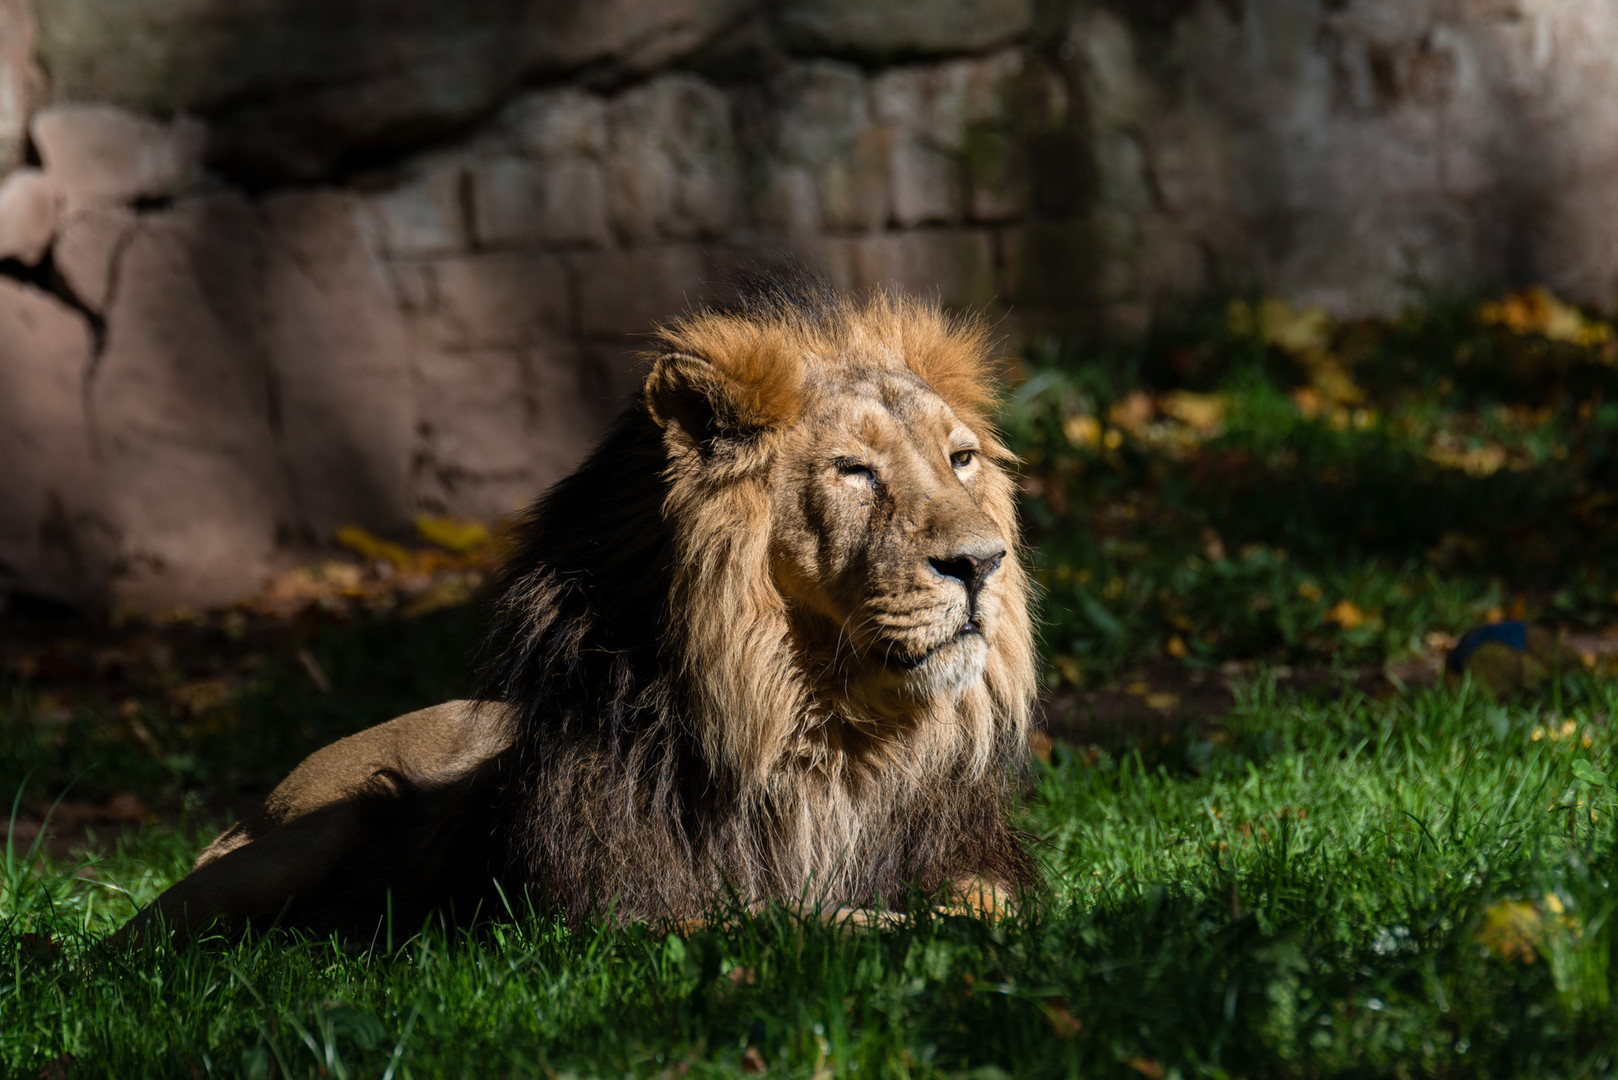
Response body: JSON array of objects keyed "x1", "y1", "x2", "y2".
[{"x1": 482, "y1": 276, "x2": 1036, "y2": 921}]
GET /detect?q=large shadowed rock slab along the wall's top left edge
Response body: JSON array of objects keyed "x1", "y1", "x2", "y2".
[{"x1": 37, "y1": 0, "x2": 743, "y2": 186}]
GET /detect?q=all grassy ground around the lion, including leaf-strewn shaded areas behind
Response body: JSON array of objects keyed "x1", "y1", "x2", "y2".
[{"x1": 0, "y1": 291, "x2": 1618, "y2": 1080}]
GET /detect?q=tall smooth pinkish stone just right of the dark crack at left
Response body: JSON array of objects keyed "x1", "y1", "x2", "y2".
[{"x1": 87, "y1": 198, "x2": 293, "y2": 604}]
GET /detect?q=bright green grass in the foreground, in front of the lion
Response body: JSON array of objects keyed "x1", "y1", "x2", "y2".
[{"x1": 0, "y1": 682, "x2": 1618, "y2": 1077}]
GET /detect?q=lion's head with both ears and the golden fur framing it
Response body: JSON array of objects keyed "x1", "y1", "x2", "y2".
[{"x1": 642, "y1": 286, "x2": 1034, "y2": 787}]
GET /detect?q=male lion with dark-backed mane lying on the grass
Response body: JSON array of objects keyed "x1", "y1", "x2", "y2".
[{"x1": 121, "y1": 285, "x2": 1037, "y2": 938}]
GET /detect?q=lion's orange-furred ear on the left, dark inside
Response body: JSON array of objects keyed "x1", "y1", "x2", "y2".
[{"x1": 644, "y1": 335, "x2": 803, "y2": 449}]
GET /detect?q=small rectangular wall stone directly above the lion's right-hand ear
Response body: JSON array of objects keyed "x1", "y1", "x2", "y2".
[{"x1": 819, "y1": 228, "x2": 997, "y2": 309}]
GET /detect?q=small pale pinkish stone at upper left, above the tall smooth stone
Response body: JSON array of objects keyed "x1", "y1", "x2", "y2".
[{"x1": 32, "y1": 105, "x2": 207, "y2": 210}]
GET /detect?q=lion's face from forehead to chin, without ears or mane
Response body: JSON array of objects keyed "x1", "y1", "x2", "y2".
[{"x1": 770, "y1": 368, "x2": 1013, "y2": 712}]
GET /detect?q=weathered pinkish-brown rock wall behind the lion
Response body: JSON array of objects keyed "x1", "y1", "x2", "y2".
[{"x1": 0, "y1": 0, "x2": 1618, "y2": 604}]
